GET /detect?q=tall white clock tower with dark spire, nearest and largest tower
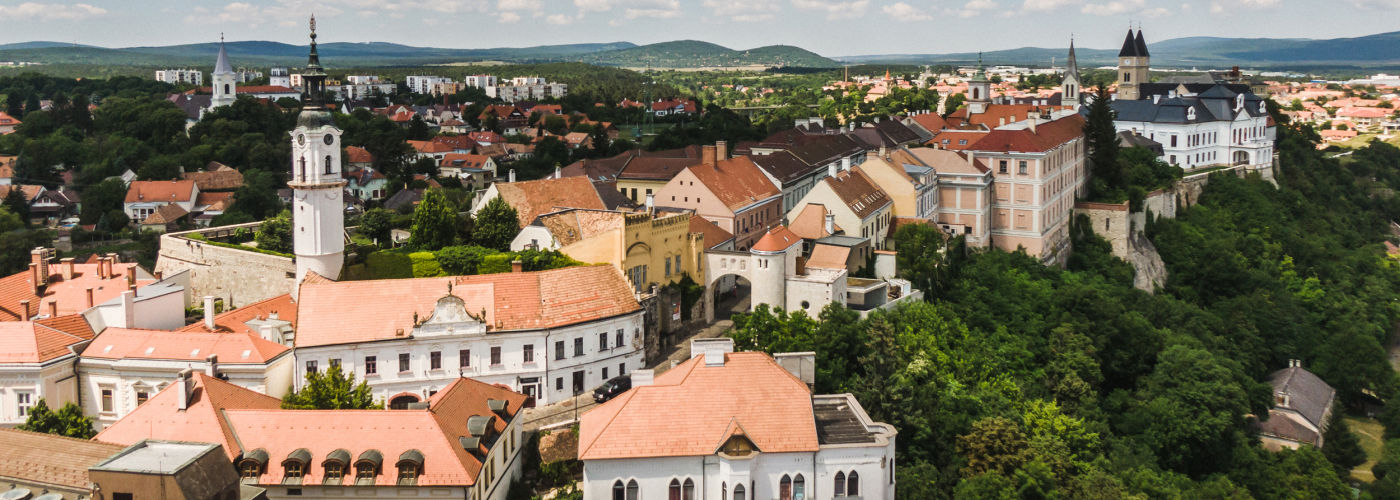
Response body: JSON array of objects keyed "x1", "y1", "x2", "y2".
[{"x1": 287, "y1": 17, "x2": 346, "y2": 288}]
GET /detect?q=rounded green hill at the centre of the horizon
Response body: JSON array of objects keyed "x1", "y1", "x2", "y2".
[{"x1": 577, "y1": 41, "x2": 839, "y2": 67}]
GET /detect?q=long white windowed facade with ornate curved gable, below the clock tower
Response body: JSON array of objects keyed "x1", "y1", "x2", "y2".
[{"x1": 297, "y1": 311, "x2": 645, "y2": 405}]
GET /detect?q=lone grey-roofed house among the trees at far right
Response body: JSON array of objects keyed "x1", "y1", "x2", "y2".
[{"x1": 1259, "y1": 360, "x2": 1337, "y2": 451}]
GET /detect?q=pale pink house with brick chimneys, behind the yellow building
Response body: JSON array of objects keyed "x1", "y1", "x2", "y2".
[{"x1": 655, "y1": 146, "x2": 783, "y2": 251}]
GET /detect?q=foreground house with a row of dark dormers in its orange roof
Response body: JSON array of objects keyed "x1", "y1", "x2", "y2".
[{"x1": 97, "y1": 373, "x2": 528, "y2": 500}]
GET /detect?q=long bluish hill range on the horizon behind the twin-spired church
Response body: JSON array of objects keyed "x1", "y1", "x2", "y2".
[{"x1": 834, "y1": 32, "x2": 1400, "y2": 67}]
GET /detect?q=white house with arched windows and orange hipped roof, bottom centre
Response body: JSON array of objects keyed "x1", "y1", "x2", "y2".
[{"x1": 578, "y1": 339, "x2": 896, "y2": 500}]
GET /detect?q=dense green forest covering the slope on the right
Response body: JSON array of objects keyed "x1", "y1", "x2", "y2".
[{"x1": 731, "y1": 127, "x2": 1400, "y2": 499}]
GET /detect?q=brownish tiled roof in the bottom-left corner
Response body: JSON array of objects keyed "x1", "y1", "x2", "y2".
[{"x1": 0, "y1": 429, "x2": 125, "y2": 492}]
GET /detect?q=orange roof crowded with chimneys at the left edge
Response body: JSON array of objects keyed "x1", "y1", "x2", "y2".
[{"x1": 0, "y1": 263, "x2": 155, "y2": 321}]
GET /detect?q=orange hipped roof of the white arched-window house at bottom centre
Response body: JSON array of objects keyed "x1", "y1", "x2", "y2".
[{"x1": 578, "y1": 353, "x2": 818, "y2": 461}]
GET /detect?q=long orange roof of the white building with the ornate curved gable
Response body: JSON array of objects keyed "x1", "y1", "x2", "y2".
[{"x1": 303, "y1": 265, "x2": 640, "y2": 347}]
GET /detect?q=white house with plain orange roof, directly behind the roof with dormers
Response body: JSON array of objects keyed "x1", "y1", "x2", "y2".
[{"x1": 77, "y1": 328, "x2": 293, "y2": 429}]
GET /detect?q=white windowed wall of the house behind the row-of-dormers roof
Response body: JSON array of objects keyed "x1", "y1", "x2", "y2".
[{"x1": 77, "y1": 354, "x2": 293, "y2": 431}]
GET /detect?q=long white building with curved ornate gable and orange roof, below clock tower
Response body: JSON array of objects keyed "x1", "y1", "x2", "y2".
[{"x1": 297, "y1": 265, "x2": 645, "y2": 406}]
